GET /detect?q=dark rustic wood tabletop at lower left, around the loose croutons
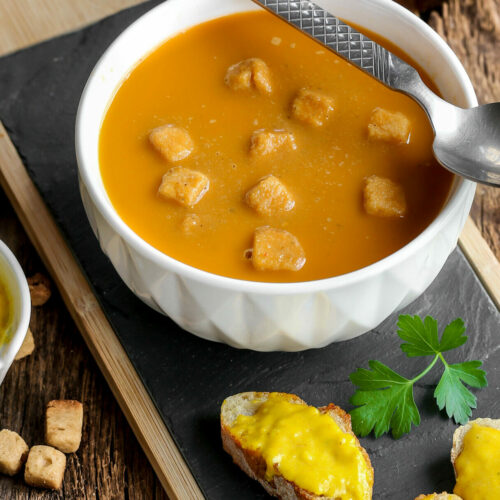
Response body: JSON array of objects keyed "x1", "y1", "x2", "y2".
[{"x1": 0, "y1": 190, "x2": 167, "y2": 500}]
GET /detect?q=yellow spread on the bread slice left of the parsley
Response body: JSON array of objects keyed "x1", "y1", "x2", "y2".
[{"x1": 231, "y1": 393, "x2": 371, "y2": 500}]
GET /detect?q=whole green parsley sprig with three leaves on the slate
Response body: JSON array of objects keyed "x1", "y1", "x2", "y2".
[{"x1": 350, "y1": 315, "x2": 488, "y2": 439}]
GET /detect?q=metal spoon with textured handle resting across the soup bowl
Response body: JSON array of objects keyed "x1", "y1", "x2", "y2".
[{"x1": 253, "y1": 0, "x2": 500, "y2": 186}]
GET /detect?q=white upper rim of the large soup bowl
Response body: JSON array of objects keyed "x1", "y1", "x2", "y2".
[{"x1": 75, "y1": 0, "x2": 478, "y2": 295}]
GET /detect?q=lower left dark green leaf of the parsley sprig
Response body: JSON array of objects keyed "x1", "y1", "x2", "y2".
[{"x1": 350, "y1": 361, "x2": 420, "y2": 439}]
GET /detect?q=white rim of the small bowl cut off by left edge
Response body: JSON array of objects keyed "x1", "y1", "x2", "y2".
[{"x1": 0, "y1": 240, "x2": 31, "y2": 384}]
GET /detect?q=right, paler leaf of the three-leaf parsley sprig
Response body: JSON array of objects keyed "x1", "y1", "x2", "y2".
[{"x1": 434, "y1": 361, "x2": 488, "y2": 425}]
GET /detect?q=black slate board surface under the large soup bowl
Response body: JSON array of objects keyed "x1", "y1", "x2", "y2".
[{"x1": 0, "y1": 2, "x2": 500, "y2": 500}]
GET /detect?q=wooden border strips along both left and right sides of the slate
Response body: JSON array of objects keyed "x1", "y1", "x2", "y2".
[{"x1": 0, "y1": 2, "x2": 500, "y2": 498}]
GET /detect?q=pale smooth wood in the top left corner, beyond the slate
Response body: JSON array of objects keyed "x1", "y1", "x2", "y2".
[{"x1": 0, "y1": 0, "x2": 144, "y2": 56}]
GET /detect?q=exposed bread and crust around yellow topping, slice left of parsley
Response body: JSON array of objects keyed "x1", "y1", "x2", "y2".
[{"x1": 221, "y1": 392, "x2": 373, "y2": 500}]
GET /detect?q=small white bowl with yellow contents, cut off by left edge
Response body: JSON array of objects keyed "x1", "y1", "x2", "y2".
[{"x1": 0, "y1": 240, "x2": 31, "y2": 384}]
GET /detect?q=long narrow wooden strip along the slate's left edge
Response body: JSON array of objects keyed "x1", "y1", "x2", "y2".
[{"x1": 0, "y1": 123, "x2": 203, "y2": 500}]
